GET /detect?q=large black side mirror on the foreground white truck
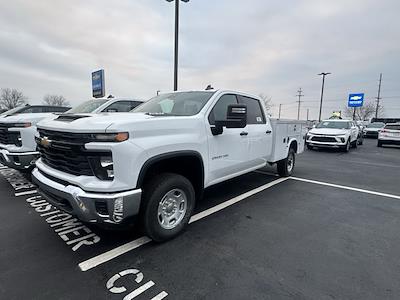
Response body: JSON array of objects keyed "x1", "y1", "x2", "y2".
[{"x1": 211, "y1": 104, "x2": 247, "y2": 135}]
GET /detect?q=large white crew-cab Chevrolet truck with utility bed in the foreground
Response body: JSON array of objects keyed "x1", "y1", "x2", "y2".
[{"x1": 32, "y1": 90, "x2": 306, "y2": 241}]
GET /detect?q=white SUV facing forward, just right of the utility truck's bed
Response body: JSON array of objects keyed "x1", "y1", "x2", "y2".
[{"x1": 306, "y1": 119, "x2": 359, "y2": 152}]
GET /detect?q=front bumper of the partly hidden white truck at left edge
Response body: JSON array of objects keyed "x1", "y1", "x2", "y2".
[{"x1": 0, "y1": 149, "x2": 40, "y2": 170}]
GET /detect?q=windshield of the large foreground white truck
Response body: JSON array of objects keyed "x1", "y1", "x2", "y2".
[{"x1": 133, "y1": 92, "x2": 214, "y2": 116}]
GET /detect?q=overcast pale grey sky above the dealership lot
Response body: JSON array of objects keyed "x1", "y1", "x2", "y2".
[{"x1": 0, "y1": 0, "x2": 400, "y2": 119}]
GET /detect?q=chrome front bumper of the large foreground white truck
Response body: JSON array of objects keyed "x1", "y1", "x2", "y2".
[{"x1": 32, "y1": 168, "x2": 142, "y2": 224}]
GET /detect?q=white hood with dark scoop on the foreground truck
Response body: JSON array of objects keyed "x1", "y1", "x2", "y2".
[{"x1": 38, "y1": 113, "x2": 155, "y2": 133}]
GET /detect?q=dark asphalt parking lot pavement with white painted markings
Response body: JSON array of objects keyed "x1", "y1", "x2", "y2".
[{"x1": 0, "y1": 139, "x2": 400, "y2": 299}]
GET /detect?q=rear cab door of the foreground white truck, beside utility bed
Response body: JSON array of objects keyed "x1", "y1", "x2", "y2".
[{"x1": 238, "y1": 95, "x2": 272, "y2": 167}]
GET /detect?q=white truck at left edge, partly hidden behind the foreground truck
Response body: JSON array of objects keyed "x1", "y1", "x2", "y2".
[{"x1": 0, "y1": 98, "x2": 142, "y2": 171}]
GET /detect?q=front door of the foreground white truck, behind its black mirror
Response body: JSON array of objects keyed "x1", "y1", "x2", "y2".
[{"x1": 206, "y1": 94, "x2": 249, "y2": 184}]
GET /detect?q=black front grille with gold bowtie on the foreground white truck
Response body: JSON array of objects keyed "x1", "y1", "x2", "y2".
[{"x1": 37, "y1": 129, "x2": 109, "y2": 176}]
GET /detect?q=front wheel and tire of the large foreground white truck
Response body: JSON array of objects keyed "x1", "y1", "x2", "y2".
[{"x1": 141, "y1": 173, "x2": 196, "y2": 242}]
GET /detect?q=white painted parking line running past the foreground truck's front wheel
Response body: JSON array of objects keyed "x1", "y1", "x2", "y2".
[{"x1": 78, "y1": 177, "x2": 289, "y2": 272}]
